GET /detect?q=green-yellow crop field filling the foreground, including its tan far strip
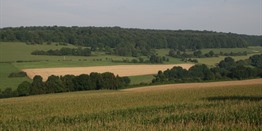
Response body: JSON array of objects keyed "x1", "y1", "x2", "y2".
[{"x1": 0, "y1": 79, "x2": 262, "y2": 130}]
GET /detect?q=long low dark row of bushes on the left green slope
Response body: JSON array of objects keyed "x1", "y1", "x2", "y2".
[{"x1": 31, "y1": 47, "x2": 91, "y2": 56}]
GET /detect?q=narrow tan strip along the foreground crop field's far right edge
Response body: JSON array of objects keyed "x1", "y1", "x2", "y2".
[{"x1": 122, "y1": 79, "x2": 262, "y2": 93}]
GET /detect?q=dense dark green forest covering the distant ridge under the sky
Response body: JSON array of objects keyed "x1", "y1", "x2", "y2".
[{"x1": 0, "y1": 26, "x2": 262, "y2": 56}]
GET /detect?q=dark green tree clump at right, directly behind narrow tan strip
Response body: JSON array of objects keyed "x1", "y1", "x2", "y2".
[{"x1": 152, "y1": 55, "x2": 262, "y2": 83}]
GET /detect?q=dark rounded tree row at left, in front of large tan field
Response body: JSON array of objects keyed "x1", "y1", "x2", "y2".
[{"x1": 0, "y1": 72, "x2": 130, "y2": 98}]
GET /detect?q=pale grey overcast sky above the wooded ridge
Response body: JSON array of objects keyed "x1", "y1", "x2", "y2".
[{"x1": 0, "y1": 0, "x2": 261, "y2": 35}]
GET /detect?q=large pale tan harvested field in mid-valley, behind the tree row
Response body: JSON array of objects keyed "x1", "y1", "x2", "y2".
[{"x1": 23, "y1": 64, "x2": 193, "y2": 80}]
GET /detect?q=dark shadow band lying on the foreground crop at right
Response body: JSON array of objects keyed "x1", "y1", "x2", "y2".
[{"x1": 204, "y1": 96, "x2": 262, "y2": 101}]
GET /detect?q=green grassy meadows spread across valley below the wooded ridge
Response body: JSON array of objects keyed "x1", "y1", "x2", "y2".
[{"x1": 0, "y1": 42, "x2": 262, "y2": 90}]
